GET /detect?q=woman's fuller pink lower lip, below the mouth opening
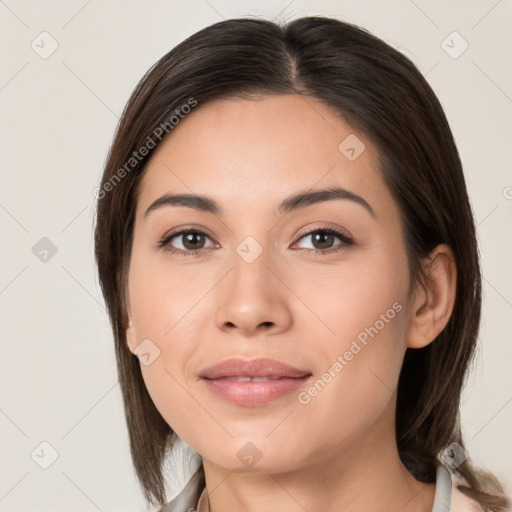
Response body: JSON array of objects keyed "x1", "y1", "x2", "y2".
[{"x1": 202, "y1": 375, "x2": 311, "y2": 407}]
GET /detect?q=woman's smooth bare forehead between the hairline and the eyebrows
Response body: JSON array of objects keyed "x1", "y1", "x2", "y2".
[{"x1": 138, "y1": 95, "x2": 391, "y2": 219}]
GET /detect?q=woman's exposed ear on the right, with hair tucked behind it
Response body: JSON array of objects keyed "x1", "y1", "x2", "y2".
[{"x1": 407, "y1": 244, "x2": 457, "y2": 348}]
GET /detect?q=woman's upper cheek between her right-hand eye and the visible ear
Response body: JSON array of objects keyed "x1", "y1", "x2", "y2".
[{"x1": 292, "y1": 242, "x2": 409, "y2": 348}]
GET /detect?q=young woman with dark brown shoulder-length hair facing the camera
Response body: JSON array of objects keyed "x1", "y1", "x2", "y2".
[{"x1": 95, "y1": 17, "x2": 510, "y2": 512}]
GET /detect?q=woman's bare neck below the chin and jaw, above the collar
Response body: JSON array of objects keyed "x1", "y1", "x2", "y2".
[{"x1": 203, "y1": 406, "x2": 435, "y2": 512}]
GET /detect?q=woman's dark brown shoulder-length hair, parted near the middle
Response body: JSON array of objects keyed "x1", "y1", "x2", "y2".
[{"x1": 95, "y1": 16, "x2": 510, "y2": 512}]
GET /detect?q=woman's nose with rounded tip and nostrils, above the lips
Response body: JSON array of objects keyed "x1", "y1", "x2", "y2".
[{"x1": 215, "y1": 245, "x2": 293, "y2": 337}]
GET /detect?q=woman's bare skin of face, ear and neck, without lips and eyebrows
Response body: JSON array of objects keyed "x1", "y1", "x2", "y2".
[{"x1": 126, "y1": 95, "x2": 456, "y2": 512}]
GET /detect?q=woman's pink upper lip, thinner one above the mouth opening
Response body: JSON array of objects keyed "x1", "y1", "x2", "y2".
[{"x1": 199, "y1": 358, "x2": 311, "y2": 379}]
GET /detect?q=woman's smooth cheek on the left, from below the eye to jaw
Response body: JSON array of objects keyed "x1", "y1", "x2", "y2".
[{"x1": 129, "y1": 249, "x2": 211, "y2": 441}]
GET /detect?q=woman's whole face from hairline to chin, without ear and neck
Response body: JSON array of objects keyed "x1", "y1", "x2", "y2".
[{"x1": 127, "y1": 95, "x2": 411, "y2": 471}]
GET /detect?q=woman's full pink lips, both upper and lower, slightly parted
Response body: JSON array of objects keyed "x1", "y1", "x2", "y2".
[{"x1": 199, "y1": 358, "x2": 311, "y2": 407}]
